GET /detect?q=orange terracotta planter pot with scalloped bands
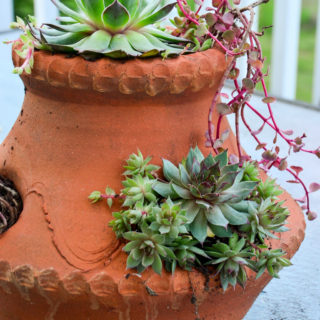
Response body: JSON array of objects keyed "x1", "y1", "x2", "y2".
[{"x1": 0, "y1": 50, "x2": 305, "y2": 320}]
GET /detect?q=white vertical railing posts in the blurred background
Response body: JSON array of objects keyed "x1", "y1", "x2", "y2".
[{"x1": 0, "y1": 0, "x2": 320, "y2": 107}]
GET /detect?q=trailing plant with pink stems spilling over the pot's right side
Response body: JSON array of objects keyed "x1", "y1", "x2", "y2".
[{"x1": 173, "y1": 0, "x2": 320, "y2": 220}]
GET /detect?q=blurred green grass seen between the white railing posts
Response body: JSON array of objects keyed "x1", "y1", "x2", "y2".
[{"x1": 15, "y1": 0, "x2": 318, "y2": 102}]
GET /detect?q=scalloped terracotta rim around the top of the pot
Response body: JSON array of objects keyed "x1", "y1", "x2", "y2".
[{"x1": 13, "y1": 48, "x2": 232, "y2": 96}]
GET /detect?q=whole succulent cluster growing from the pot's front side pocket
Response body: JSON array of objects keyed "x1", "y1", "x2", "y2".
[{"x1": 89, "y1": 147, "x2": 290, "y2": 290}]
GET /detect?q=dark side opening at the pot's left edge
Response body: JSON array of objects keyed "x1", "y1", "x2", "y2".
[{"x1": 0, "y1": 176, "x2": 23, "y2": 235}]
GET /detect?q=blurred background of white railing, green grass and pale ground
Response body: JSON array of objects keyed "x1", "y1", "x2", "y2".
[{"x1": 0, "y1": 0, "x2": 320, "y2": 320}]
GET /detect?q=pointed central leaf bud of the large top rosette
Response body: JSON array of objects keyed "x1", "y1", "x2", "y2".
[{"x1": 102, "y1": 0, "x2": 130, "y2": 31}]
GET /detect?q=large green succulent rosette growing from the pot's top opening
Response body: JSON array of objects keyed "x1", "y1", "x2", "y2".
[{"x1": 32, "y1": 0, "x2": 188, "y2": 58}]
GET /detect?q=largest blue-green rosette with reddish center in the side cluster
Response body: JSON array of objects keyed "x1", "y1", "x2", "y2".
[{"x1": 154, "y1": 147, "x2": 257, "y2": 243}]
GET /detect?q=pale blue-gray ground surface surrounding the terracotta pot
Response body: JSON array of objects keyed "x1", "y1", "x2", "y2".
[{"x1": 0, "y1": 33, "x2": 320, "y2": 320}]
